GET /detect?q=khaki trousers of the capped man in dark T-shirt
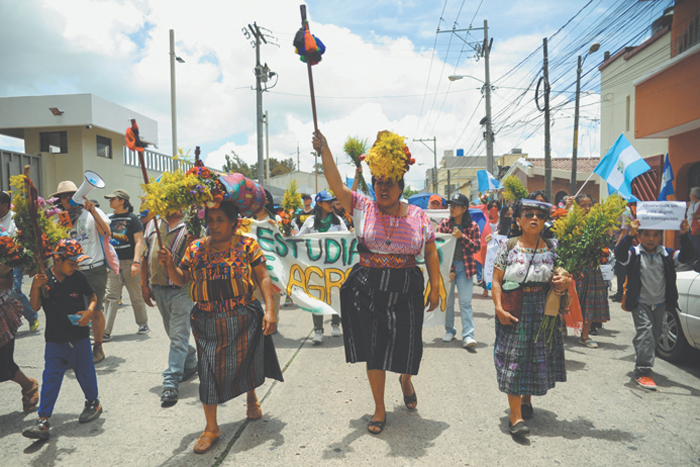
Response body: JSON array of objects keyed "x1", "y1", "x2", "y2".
[{"x1": 105, "y1": 259, "x2": 148, "y2": 334}]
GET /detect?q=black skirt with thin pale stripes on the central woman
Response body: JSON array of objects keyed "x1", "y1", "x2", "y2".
[{"x1": 340, "y1": 265, "x2": 424, "y2": 375}]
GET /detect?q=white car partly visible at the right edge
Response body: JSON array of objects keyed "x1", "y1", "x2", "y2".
[{"x1": 656, "y1": 261, "x2": 700, "y2": 362}]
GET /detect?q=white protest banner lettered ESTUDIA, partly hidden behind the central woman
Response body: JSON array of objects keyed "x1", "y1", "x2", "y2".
[{"x1": 239, "y1": 219, "x2": 456, "y2": 324}]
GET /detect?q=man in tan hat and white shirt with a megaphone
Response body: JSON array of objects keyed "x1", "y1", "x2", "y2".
[{"x1": 51, "y1": 180, "x2": 112, "y2": 363}]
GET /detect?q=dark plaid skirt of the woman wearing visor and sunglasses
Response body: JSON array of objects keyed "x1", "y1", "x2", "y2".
[{"x1": 493, "y1": 288, "x2": 566, "y2": 396}]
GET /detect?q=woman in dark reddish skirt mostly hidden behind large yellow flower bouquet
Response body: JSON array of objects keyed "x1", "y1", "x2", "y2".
[{"x1": 576, "y1": 193, "x2": 610, "y2": 349}]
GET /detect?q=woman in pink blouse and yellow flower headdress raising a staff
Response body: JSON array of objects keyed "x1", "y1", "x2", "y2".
[{"x1": 313, "y1": 131, "x2": 441, "y2": 434}]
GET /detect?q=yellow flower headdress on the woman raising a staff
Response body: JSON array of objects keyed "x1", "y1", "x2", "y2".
[{"x1": 364, "y1": 130, "x2": 416, "y2": 182}]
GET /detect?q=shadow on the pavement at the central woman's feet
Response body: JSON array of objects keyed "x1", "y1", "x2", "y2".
[{"x1": 323, "y1": 406, "x2": 450, "y2": 459}]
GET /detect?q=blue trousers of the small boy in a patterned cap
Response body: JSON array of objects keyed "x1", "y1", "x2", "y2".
[{"x1": 39, "y1": 337, "x2": 97, "y2": 417}]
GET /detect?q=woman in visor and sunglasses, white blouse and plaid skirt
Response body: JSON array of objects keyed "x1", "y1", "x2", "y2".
[{"x1": 492, "y1": 199, "x2": 571, "y2": 435}]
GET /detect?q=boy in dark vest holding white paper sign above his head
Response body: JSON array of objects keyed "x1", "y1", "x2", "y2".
[{"x1": 615, "y1": 219, "x2": 694, "y2": 391}]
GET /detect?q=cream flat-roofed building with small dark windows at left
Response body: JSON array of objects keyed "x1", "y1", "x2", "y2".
[{"x1": 0, "y1": 94, "x2": 178, "y2": 202}]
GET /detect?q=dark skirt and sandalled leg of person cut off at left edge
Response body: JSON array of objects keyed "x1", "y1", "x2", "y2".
[{"x1": 0, "y1": 268, "x2": 39, "y2": 412}]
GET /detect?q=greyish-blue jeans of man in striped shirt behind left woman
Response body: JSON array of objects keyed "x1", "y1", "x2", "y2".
[{"x1": 151, "y1": 285, "x2": 197, "y2": 389}]
